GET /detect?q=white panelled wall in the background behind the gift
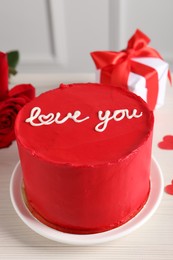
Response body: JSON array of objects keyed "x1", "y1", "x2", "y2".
[{"x1": 0, "y1": 0, "x2": 173, "y2": 72}]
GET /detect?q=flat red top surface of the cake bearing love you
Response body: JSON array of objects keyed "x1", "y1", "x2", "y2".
[{"x1": 15, "y1": 83, "x2": 153, "y2": 166}]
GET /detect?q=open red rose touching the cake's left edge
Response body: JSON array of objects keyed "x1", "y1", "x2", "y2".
[{"x1": 0, "y1": 84, "x2": 35, "y2": 148}]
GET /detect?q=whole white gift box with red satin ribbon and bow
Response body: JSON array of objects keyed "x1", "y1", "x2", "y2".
[{"x1": 91, "y1": 30, "x2": 171, "y2": 110}]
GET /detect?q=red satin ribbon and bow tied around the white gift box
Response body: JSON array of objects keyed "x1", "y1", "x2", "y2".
[{"x1": 91, "y1": 30, "x2": 171, "y2": 110}]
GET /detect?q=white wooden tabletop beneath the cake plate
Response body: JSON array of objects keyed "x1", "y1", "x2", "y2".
[{"x1": 0, "y1": 74, "x2": 173, "y2": 260}]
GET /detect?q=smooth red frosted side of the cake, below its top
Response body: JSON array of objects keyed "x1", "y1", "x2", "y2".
[{"x1": 19, "y1": 132, "x2": 151, "y2": 234}]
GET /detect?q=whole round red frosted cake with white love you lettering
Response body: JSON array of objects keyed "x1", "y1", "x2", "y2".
[{"x1": 15, "y1": 83, "x2": 154, "y2": 234}]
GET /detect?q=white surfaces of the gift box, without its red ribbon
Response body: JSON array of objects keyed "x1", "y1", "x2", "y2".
[{"x1": 96, "y1": 58, "x2": 169, "y2": 109}]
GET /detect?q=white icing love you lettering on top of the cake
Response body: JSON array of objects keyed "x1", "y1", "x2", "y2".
[{"x1": 25, "y1": 107, "x2": 142, "y2": 132}]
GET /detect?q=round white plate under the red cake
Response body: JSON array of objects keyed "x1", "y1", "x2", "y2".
[{"x1": 10, "y1": 159, "x2": 163, "y2": 246}]
